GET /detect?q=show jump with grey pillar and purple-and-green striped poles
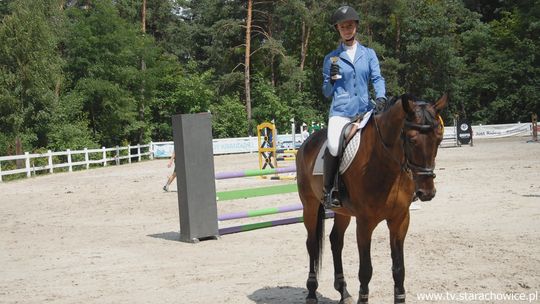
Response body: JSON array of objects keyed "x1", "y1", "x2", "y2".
[{"x1": 172, "y1": 113, "x2": 333, "y2": 243}]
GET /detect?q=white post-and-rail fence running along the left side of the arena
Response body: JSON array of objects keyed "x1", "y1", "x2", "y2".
[{"x1": 0, "y1": 143, "x2": 154, "y2": 182}]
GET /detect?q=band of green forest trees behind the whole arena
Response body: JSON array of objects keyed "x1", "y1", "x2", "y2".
[{"x1": 0, "y1": 0, "x2": 540, "y2": 155}]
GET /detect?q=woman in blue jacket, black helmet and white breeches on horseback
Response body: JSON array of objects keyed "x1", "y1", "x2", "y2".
[{"x1": 322, "y1": 6, "x2": 386, "y2": 208}]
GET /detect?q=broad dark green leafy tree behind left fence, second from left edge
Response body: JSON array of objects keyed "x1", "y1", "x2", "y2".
[{"x1": 65, "y1": 1, "x2": 160, "y2": 146}]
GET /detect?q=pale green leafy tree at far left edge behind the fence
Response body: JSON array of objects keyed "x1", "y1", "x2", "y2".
[{"x1": 0, "y1": 0, "x2": 62, "y2": 146}]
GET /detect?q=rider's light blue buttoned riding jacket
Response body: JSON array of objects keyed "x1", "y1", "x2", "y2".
[{"x1": 322, "y1": 42, "x2": 386, "y2": 117}]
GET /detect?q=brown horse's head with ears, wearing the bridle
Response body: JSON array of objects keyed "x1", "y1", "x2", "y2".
[{"x1": 401, "y1": 94, "x2": 448, "y2": 201}]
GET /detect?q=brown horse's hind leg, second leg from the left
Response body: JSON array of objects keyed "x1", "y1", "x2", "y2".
[{"x1": 330, "y1": 214, "x2": 354, "y2": 304}]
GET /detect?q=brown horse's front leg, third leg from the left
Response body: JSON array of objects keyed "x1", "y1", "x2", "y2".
[{"x1": 356, "y1": 217, "x2": 374, "y2": 304}]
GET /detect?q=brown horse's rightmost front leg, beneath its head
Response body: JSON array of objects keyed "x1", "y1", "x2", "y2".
[{"x1": 388, "y1": 212, "x2": 409, "y2": 304}]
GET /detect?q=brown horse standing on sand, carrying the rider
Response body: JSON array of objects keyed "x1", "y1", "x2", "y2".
[{"x1": 296, "y1": 95, "x2": 447, "y2": 303}]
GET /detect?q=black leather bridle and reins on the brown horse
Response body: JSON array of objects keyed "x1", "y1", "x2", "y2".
[{"x1": 373, "y1": 101, "x2": 439, "y2": 178}]
